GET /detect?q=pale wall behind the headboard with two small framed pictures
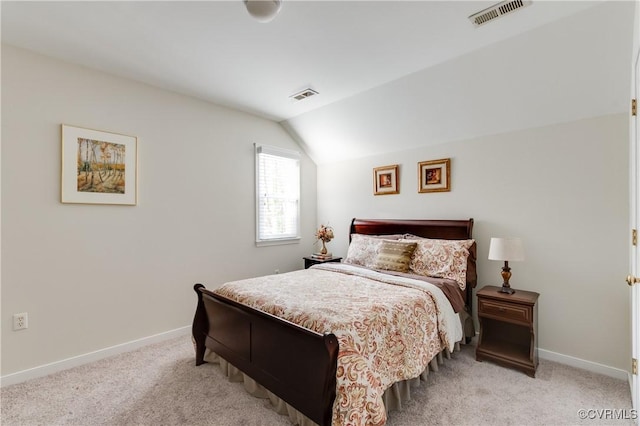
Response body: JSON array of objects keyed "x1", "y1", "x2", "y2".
[{"x1": 318, "y1": 114, "x2": 630, "y2": 370}]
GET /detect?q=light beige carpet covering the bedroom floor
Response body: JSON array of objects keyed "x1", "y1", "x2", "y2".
[{"x1": 0, "y1": 337, "x2": 633, "y2": 426}]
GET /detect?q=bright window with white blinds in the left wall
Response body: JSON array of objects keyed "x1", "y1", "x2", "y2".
[{"x1": 256, "y1": 145, "x2": 300, "y2": 245}]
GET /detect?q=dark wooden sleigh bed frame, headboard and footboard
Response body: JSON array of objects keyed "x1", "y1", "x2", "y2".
[{"x1": 193, "y1": 219, "x2": 477, "y2": 425}]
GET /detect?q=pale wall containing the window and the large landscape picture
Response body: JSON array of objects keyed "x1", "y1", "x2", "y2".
[{"x1": 1, "y1": 46, "x2": 316, "y2": 376}]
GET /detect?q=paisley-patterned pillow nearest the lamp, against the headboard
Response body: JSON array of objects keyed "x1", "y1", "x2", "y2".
[{"x1": 400, "y1": 235, "x2": 475, "y2": 290}]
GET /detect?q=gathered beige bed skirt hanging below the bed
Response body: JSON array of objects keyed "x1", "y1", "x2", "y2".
[{"x1": 204, "y1": 343, "x2": 460, "y2": 426}]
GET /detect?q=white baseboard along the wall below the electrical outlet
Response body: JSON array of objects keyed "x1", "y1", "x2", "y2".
[{"x1": 0, "y1": 325, "x2": 191, "y2": 386}]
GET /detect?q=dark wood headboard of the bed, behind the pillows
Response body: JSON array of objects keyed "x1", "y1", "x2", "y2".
[{"x1": 349, "y1": 218, "x2": 478, "y2": 306}]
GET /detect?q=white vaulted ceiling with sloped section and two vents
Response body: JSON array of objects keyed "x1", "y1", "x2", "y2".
[{"x1": 1, "y1": 0, "x2": 634, "y2": 163}]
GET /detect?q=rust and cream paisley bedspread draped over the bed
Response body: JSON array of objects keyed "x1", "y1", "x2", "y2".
[{"x1": 215, "y1": 263, "x2": 462, "y2": 426}]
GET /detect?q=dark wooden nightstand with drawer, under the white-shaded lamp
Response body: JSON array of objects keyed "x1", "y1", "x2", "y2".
[{"x1": 476, "y1": 286, "x2": 540, "y2": 377}]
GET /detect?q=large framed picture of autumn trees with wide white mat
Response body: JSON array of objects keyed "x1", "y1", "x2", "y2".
[{"x1": 61, "y1": 124, "x2": 138, "y2": 206}]
